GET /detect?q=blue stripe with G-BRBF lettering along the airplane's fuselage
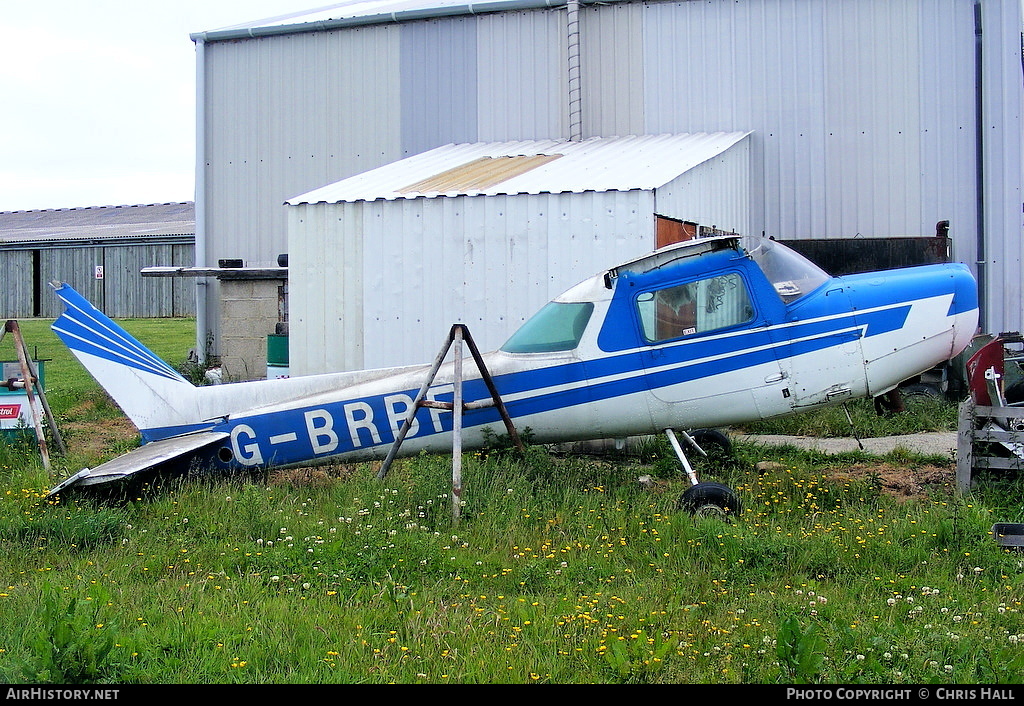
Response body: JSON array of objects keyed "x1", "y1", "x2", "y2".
[{"x1": 211, "y1": 304, "x2": 910, "y2": 464}]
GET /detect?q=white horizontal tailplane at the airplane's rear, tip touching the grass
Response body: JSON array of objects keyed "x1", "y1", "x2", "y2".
[{"x1": 49, "y1": 431, "x2": 229, "y2": 496}]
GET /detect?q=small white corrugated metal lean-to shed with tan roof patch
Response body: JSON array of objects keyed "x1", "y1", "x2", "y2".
[{"x1": 289, "y1": 133, "x2": 750, "y2": 374}]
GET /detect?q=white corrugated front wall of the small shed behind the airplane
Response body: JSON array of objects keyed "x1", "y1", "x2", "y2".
[{"x1": 289, "y1": 191, "x2": 654, "y2": 374}]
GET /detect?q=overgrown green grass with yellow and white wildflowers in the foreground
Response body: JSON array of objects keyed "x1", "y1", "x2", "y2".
[{"x1": 0, "y1": 322, "x2": 1024, "y2": 684}]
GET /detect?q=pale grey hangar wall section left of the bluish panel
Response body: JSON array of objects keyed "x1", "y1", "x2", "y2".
[{"x1": 197, "y1": 25, "x2": 402, "y2": 341}]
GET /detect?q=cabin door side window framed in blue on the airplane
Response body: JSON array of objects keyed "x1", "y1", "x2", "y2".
[{"x1": 636, "y1": 273, "x2": 754, "y2": 343}]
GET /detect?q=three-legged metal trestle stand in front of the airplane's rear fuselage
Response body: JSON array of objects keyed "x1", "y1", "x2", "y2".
[{"x1": 377, "y1": 324, "x2": 523, "y2": 518}]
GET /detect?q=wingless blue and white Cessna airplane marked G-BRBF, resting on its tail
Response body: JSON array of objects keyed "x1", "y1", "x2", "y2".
[{"x1": 44, "y1": 236, "x2": 978, "y2": 512}]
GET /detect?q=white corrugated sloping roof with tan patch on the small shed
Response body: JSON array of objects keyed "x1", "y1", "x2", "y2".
[{"x1": 288, "y1": 132, "x2": 748, "y2": 206}]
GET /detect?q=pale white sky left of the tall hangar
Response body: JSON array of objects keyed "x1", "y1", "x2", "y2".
[{"x1": 0, "y1": 0, "x2": 319, "y2": 211}]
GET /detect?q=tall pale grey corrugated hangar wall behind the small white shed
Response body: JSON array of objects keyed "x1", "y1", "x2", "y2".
[{"x1": 198, "y1": 0, "x2": 1024, "y2": 358}]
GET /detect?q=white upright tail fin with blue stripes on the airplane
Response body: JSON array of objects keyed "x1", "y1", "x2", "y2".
[{"x1": 51, "y1": 283, "x2": 199, "y2": 434}]
